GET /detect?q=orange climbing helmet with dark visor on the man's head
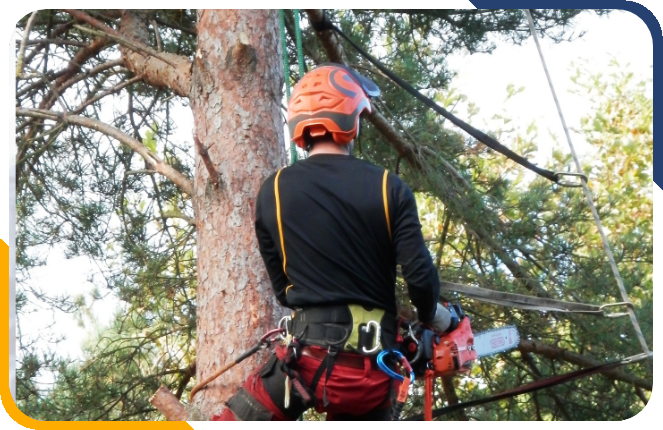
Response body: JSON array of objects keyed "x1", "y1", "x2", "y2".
[{"x1": 288, "y1": 63, "x2": 380, "y2": 149}]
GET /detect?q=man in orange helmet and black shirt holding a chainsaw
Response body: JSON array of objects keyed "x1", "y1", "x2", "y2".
[{"x1": 219, "y1": 63, "x2": 450, "y2": 420}]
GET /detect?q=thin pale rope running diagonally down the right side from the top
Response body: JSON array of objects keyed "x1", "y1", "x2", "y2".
[{"x1": 524, "y1": 9, "x2": 652, "y2": 355}]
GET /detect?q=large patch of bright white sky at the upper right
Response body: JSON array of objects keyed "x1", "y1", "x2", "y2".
[{"x1": 448, "y1": 11, "x2": 653, "y2": 165}]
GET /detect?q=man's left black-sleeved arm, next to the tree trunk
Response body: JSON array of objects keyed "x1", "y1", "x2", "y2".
[{"x1": 255, "y1": 181, "x2": 290, "y2": 306}]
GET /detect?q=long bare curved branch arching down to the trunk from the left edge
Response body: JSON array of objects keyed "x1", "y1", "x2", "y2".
[{"x1": 16, "y1": 108, "x2": 193, "y2": 195}]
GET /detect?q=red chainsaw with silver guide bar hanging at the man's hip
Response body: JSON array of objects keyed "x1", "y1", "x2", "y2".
[{"x1": 401, "y1": 303, "x2": 520, "y2": 420}]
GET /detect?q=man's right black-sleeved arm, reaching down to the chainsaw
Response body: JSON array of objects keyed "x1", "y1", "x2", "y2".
[{"x1": 392, "y1": 178, "x2": 440, "y2": 322}]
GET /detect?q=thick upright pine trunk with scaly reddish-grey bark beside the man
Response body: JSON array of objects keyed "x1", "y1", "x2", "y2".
[{"x1": 190, "y1": 10, "x2": 285, "y2": 417}]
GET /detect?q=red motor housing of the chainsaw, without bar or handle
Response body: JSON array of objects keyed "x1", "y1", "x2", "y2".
[{"x1": 433, "y1": 317, "x2": 477, "y2": 377}]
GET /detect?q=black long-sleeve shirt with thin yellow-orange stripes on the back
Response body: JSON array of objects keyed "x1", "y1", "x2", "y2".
[{"x1": 255, "y1": 154, "x2": 440, "y2": 321}]
